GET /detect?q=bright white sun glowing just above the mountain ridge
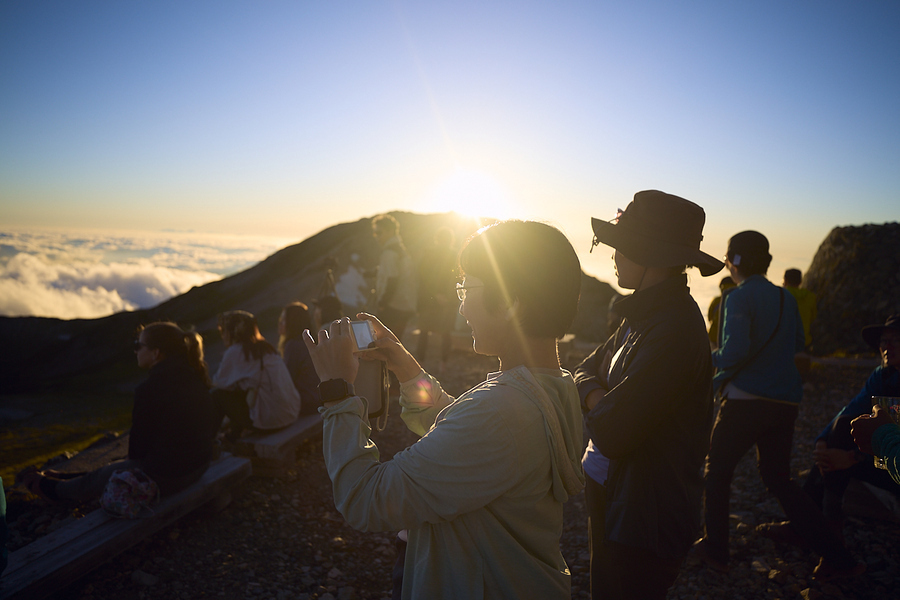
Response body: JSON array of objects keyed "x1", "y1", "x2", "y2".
[{"x1": 421, "y1": 169, "x2": 520, "y2": 219}]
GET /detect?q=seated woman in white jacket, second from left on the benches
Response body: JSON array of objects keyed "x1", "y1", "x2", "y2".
[{"x1": 212, "y1": 310, "x2": 300, "y2": 441}]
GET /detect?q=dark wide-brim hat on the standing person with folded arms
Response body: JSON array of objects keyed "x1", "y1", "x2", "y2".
[{"x1": 591, "y1": 190, "x2": 725, "y2": 277}]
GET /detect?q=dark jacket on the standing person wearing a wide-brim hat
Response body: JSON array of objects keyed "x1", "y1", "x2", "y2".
[{"x1": 575, "y1": 275, "x2": 713, "y2": 558}]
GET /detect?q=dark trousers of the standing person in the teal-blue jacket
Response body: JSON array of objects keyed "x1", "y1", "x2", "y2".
[{"x1": 704, "y1": 398, "x2": 854, "y2": 568}]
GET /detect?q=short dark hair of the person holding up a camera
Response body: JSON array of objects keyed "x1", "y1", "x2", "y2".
[{"x1": 459, "y1": 220, "x2": 581, "y2": 338}]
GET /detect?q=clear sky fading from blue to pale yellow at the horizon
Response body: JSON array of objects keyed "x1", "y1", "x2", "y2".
[{"x1": 0, "y1": 0, "x2": 900, "y2": 318}]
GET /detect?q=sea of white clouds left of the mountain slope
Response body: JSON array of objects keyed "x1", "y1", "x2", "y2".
[{"x1": 0, "y1": 230, "x2": 291, "y2": 319}]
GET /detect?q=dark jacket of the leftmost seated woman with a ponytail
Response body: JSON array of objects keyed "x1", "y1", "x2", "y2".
[{"x1": 128, "y1": 358, "x2": 218, "y2": 487}]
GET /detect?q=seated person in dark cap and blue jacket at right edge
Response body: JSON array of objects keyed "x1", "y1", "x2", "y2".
[{"x1": 760, "y1": 315, "x2": 900, "y2": 543}]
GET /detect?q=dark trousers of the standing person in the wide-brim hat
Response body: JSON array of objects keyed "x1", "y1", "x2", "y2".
[{"x1": 584, "y1": 477, "x2": 683, "y2": 600}]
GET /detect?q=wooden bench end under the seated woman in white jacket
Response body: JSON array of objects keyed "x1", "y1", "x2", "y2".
[{"x1": 238, "y1": 413, "x2": 322, "y2": 477}]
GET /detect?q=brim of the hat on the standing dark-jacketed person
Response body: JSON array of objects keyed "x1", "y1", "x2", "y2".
[{"x1": 591, "y1": 218, "x2": 725, "y2": 277}]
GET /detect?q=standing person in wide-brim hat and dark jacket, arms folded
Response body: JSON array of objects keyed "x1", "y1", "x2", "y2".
[{"x1": 575, "y1": 190, "x2": 724, "y2": 598}]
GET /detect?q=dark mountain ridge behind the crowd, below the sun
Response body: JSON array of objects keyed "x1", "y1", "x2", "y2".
[{"x1": 0, "y1": 212, "x2": 614, "y2": 394}]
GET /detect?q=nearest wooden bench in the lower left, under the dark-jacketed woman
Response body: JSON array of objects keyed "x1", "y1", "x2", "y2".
[{"x1": 0, "y1": 454, "x2": 252, "y2": 600}]
